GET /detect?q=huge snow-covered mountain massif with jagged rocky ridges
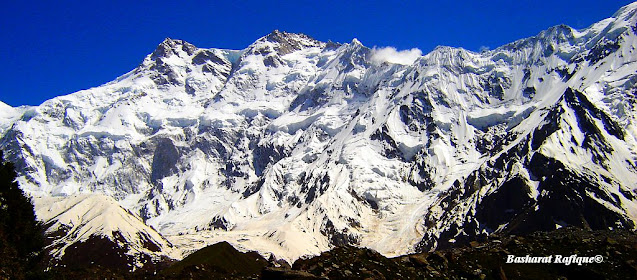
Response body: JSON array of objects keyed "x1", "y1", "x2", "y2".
[{"x1": 0, "y1": 3, "x2": 637, "y2": 260}]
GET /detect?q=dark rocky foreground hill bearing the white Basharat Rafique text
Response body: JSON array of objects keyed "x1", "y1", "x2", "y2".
[{"x1": 41, "y1": 228, "x2": 637, "y2": 279}]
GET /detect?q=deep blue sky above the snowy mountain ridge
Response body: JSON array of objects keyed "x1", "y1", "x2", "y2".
[{"x1": 0, "y1": 0, "x2": 631, "y2": 106}]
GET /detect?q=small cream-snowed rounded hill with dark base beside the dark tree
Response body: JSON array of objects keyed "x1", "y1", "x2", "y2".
[{"x1": 33, "y1": 194, "x2": 179, "y2": 270}]
